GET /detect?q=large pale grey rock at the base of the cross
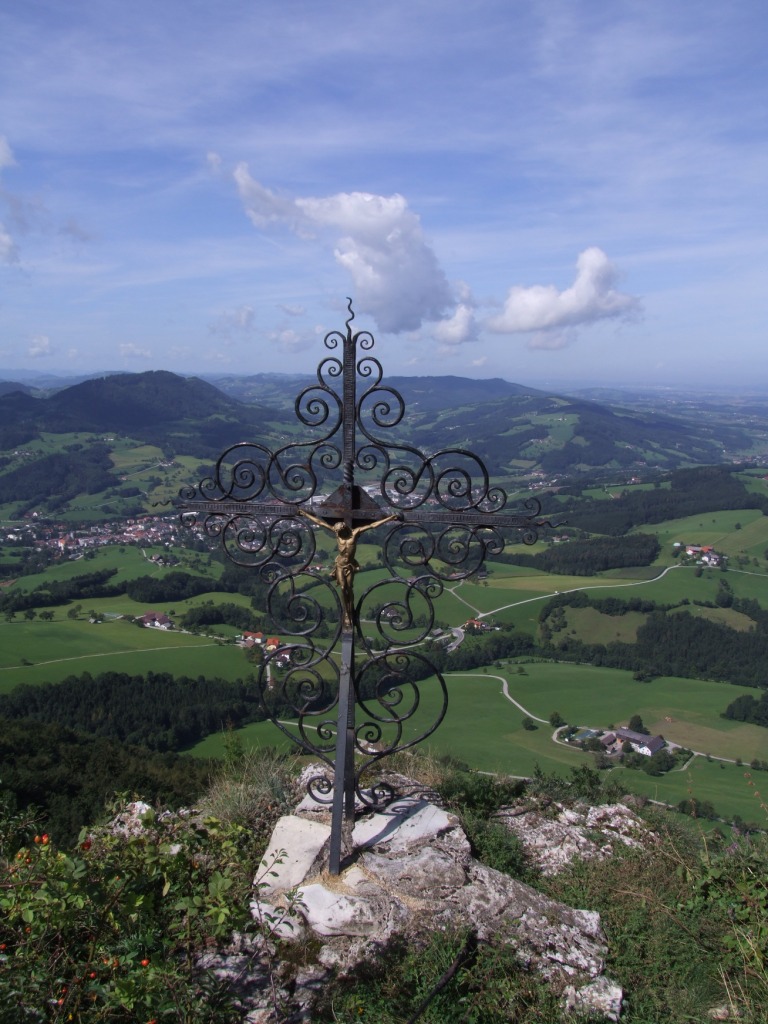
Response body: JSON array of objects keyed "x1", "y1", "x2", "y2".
[{"x1": 253, "y1": 778, "x2": 622, "y2": 1020}]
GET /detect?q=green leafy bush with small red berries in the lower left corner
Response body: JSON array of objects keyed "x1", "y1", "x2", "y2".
[{"x1": 0, "y1": 807, "x2": 258, "y2": 1024}]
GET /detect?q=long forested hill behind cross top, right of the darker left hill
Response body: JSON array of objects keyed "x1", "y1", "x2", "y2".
[{"x1": 207, "y1": 374, "x2": 753, "y2": 475}]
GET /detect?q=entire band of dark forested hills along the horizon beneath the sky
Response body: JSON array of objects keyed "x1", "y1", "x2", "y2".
[{"x1": 0, "y1": 370, "x2": 765, "y2": 477}]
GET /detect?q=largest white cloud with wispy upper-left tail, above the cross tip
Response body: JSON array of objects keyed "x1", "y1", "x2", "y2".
[{"x1": 234, "y1": 164, "x2": 455, "y2": 333}]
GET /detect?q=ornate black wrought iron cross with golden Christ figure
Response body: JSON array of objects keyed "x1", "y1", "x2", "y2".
[{"x1": 178, "y1": 300, "x2": 551, "y2": 874}]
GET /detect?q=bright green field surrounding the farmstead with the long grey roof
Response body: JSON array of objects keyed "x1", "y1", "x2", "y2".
[{"x1": 187, "y1": 663, "x2": 768, "y2": 820}]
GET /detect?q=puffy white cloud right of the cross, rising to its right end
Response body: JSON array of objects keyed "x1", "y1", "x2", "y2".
[{"x1": 485, "y1": 246, "x2": 640, "y2": 333}]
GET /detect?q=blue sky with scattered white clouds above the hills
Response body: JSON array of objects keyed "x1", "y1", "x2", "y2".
[{"x1": 0, "y1": 0, "x2": 768, "y2": 388}]
